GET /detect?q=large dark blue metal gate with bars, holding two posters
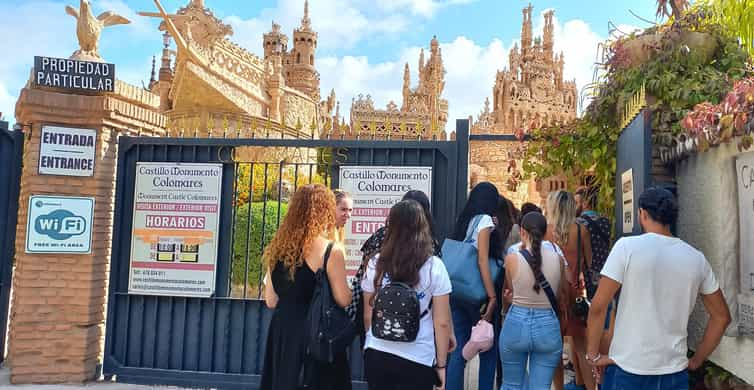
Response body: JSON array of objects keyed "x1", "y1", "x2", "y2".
[{"x1": 103, "y1": 120, "x2": 468, "y2": 389}]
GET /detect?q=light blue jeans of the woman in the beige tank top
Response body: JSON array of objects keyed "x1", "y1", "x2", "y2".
[{"x1": 500, "y1": 305, "x2": 563, "y2": 390}]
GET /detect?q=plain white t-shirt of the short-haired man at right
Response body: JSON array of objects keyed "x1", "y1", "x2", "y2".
[{"x1": 602, "y1": 233, "x2": 719, "y2": 375}]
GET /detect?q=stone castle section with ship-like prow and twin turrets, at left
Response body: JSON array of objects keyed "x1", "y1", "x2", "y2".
[{"x1": 140, "y1": 0, "x2": 335, "y2": 137}]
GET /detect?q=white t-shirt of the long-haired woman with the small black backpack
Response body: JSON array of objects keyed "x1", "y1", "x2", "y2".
[{"x1": 361, "y1": 255, "x2": 451, "y2": 367}]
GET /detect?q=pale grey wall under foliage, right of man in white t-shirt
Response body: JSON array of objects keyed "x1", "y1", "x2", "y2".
[{"x1": 676, "y1": 141, "x2": 754, "y2": 383}]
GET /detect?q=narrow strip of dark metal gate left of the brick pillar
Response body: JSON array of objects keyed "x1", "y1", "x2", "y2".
[{"x1": 0, "y1": 122, "x2": 24, "y2": 362}]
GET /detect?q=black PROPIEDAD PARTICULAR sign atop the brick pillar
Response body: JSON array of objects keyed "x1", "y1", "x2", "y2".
[{"x1": 34, "y1": 56, "x2": 115, "y2": 92}]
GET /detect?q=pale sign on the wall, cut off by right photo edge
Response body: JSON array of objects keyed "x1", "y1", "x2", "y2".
[{"x1": 736, "y1": 153, "x2": 754, "y2": 335}]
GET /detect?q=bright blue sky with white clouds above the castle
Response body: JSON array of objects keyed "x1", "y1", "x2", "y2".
[{"x1": 0, "y1": 0, "x2": 655, "y2": 123}]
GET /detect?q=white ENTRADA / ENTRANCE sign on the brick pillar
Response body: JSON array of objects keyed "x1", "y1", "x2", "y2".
[{"x1": 39, "y1": 126, "x2": 97, "y2": 176}]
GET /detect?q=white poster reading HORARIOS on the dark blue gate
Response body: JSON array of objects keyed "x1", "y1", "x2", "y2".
[{"x1": 128, "y1": 162, "x2": 222, "y2": 297}]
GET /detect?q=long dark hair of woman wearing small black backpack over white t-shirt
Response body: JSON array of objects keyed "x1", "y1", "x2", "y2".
[{"x1": 374, "y1": 200, "x2": 433, "y2": 291}]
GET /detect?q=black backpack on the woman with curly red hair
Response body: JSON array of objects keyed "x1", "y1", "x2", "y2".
[{"x1": 306, "y1": 243, "x2": 356, "y2": 363}]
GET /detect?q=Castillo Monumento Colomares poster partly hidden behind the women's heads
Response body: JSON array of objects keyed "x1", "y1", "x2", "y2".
[{"x1": 339, "y1": 166, "x2": 432, "y2": 285}]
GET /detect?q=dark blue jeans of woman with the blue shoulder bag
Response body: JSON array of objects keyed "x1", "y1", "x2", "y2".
[{"x1": 445, "y1": 299, "x2": 499, "y2": 390}]
